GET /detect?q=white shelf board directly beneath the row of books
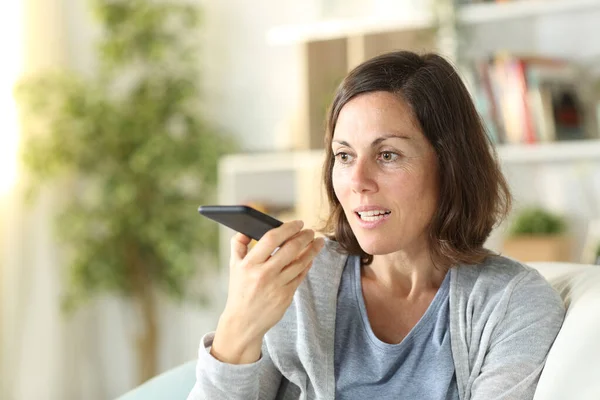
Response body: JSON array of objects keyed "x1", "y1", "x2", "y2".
[{"x1": 497, "y1": 139, "x2": 600, "y2": 164}]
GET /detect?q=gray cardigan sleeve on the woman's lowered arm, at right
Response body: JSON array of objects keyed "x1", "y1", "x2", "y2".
[{"x1": 465, "y1": 270, "x2": 565, "y2": 400}]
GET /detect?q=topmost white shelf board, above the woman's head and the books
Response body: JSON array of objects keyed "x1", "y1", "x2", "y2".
[{"x1": 267, "y1": 0, "x2": 600, "y2": 45}]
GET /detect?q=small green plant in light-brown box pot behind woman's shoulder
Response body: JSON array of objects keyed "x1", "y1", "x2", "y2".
[{"x1": 503, "y1": 207, "x2": 571, "y2": 261}]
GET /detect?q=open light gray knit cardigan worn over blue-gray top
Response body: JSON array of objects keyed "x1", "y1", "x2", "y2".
[{"x1": 188, "y1": 241, "x2": 565, "y2": 400}]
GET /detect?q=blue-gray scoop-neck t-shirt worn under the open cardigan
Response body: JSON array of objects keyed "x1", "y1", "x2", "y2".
[{"x1": 334, "y1": 257, "x2": 459, "y2": 400}]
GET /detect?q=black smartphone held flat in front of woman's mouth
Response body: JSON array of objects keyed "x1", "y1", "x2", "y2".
[{"x1": 198, "y1": 205, "x2": 283, "y2": 240}]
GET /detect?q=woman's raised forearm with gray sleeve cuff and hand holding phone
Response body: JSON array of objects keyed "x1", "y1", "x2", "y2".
[{"x1": 188, "y1": 221, "x2": 325, "y2": 400}]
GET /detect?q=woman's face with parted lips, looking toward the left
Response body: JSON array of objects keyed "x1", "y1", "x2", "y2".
[{"x1": 331, "y1": 92, "x2": 438, "y2": 255}]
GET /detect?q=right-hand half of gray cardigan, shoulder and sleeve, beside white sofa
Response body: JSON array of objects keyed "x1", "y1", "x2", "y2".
[{"x1": 450, "y1": 255, "x2": 565, "y2": 398}]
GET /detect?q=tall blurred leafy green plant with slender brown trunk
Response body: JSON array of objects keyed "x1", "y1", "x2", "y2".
[{"x1": 16, "y1": 0, "x2": 232, "y2": 381}]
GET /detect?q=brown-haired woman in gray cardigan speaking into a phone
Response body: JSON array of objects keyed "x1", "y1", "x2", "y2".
[{"x1": 190, "y1": 52, "x2": 564, "y2": 400}]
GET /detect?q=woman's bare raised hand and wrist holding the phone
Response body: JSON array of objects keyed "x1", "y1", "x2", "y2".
[{"x1": 211, "y1": 221, "x2": 324, "y2": 364}]
